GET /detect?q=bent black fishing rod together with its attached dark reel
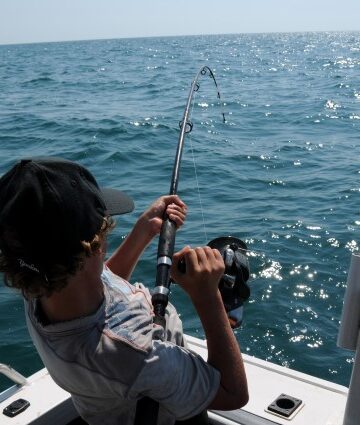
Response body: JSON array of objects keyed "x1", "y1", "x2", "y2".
[{"x1": 152, "y1": 66, "x2": 250, "y2": 328}]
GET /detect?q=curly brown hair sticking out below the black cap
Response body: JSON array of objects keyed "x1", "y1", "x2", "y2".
[{"x1": 0, "y1": 217, "x2": 115, "y2": 299}]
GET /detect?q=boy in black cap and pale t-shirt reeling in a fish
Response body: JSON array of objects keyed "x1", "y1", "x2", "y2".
[{"x1": 0, "y1": 158, "x2": 248, "y2": 425}]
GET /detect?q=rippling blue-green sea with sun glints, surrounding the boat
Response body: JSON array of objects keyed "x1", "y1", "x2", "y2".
[{"x1": 0, "y1": 32, "x2": 360, "y2": 389}]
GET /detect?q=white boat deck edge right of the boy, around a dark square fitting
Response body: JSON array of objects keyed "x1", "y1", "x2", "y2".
[{"x1": 186, "y1": 336, "x2": 348, "y2": 425}]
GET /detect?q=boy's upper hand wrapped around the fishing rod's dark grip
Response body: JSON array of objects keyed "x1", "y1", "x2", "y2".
[{"x1": 137, "y1": 195, "x2": 187, "y2": 238}]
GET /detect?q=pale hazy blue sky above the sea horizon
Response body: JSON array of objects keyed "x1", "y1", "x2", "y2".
[{"x1": 0, "y1": 0, "x2": 360, "y2": 44}]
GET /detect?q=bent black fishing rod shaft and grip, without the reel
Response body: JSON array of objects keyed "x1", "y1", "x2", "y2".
[{"x1": 152, "y1": 66, "x2": 226, "y2": 328}]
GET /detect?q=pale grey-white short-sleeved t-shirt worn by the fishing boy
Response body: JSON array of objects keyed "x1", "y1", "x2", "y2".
[{"x1": 25, "y1": 266, "x2": 220, "y2": 425}]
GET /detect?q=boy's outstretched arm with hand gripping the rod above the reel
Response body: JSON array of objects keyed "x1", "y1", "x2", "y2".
[{"x1": 106, "y1": 195, "x2": 187, "y2": 280}]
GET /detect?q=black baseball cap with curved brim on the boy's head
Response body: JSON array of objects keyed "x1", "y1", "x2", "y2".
[{"x1": 0, "y1": 157, "x2": 134, "y2": 263}]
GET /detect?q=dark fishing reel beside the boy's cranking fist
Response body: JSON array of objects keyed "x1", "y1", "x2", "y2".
[{"x1": 208, "y1": 236, "x2": 250, "y2": 329}]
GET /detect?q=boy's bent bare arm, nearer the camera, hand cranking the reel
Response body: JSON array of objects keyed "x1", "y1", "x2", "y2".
[{"x1": 172, "y1": 247, "x2": 249, "y2": 410}]
